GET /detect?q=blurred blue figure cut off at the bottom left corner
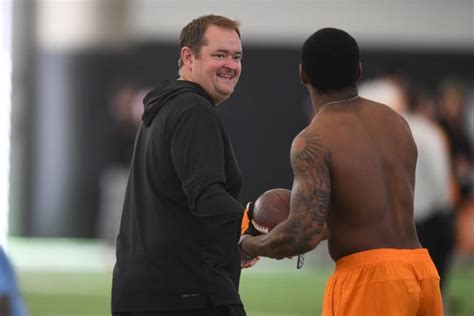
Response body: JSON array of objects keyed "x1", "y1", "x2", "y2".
[{"x1": 0, "y1": 245, "x2": 27, "y2": 316}]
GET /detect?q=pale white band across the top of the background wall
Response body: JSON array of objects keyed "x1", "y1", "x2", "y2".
[{"x1": 37, "y1": 0, "x2": 474, "y2": 50}]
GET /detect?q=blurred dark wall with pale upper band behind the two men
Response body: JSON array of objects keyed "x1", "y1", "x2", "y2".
[{"x1": 11, "y1": 0, "x2": 474, "y2": 238}]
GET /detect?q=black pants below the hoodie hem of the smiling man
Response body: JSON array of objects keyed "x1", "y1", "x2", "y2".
[{"x1": 112, "y1": 305, "x2": 247, "y2": 316}]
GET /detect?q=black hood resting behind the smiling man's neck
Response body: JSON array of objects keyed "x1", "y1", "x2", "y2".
[{"x1": 142, "y1": 80, "x2": 214, "y2": 127}]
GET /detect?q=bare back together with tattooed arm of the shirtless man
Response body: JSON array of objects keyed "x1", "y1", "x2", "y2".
[{"x1": 241, "y1": 98, "x2": 421, "y2": 260}]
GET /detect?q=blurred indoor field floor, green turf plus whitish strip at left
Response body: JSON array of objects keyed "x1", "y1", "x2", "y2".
[{"x1": 10, "y1": 240, "x2": 474, "y2": 316}]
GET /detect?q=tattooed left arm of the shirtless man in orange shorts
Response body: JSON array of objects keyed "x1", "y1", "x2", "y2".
[{"x1": 241, "y1": 128, "x2": 331, "y2": 258}]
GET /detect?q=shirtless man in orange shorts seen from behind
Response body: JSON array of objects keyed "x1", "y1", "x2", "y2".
[{"x1": 240, "y1": 28, "x2": 442, "y2": 316}]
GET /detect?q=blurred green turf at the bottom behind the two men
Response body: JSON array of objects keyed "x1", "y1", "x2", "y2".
[{"x1": 19, "y1": 266, "x2": 474, "y2": 316}]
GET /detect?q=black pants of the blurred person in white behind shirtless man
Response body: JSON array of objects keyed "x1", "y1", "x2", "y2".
[{"x1": 416, "y1": 210, "x2": 456, "y2": 290}]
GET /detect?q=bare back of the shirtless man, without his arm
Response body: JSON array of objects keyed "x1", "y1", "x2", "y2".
[{"x1": 307, "y1": 98, "x2": 420, "y2": 260}]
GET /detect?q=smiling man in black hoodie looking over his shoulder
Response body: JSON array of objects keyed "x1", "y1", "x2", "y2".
[{"x1": 112, "y1": 15, "x2": 249, "y2": 316}]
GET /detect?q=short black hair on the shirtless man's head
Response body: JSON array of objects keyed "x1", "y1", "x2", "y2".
[{"x1": 301, "y1": 28, "x2": 360, "y2": 93}]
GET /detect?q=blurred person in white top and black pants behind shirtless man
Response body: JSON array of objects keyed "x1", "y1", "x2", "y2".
[{"x1": 402, "y1": 85, "x2": 456, "y2": 299}]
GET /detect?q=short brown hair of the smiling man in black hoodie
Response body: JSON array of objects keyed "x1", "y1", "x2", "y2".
[{"x1": 178, "y1": 14, "x2": 240, "y2": 68}]
